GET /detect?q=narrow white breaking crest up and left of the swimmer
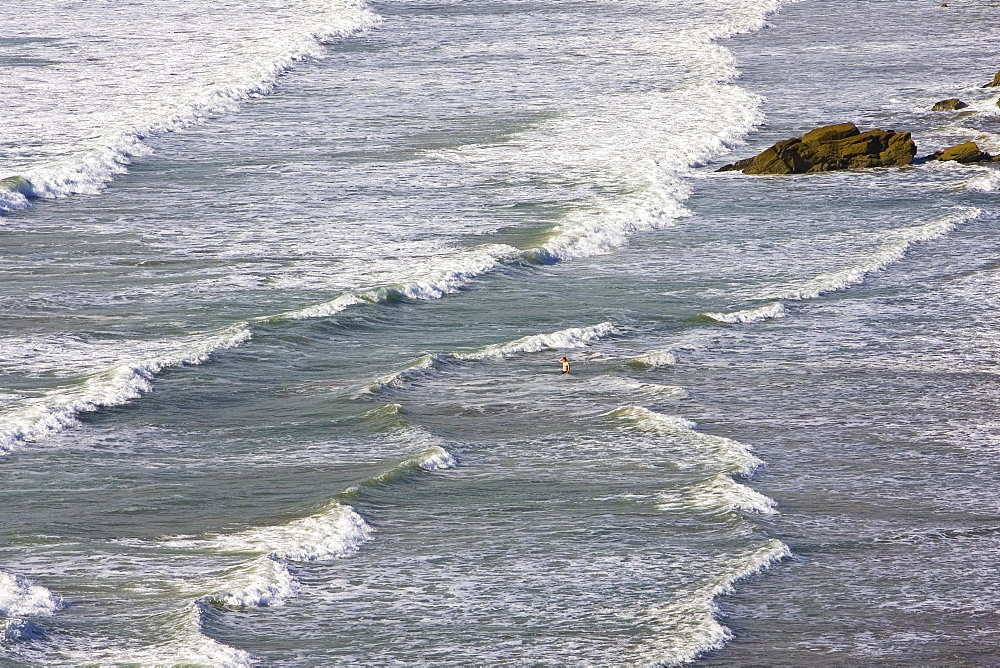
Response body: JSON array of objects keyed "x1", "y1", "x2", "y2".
[{"x1": 278, "y1": 244, "x2": 521, "y2": 321}]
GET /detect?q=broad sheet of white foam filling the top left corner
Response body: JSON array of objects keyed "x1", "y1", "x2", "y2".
[{"x1": 0, "y1": 0, "x2": 380, "y2": 211}]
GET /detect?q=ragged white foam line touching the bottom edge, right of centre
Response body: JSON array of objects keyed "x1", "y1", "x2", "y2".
[{"x1": 640, "y1": 539, "x2": 792, "y2": 666}]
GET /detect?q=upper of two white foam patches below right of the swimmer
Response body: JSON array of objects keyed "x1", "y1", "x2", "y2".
[{"x1": 611, "y1": 406, "x2": 763, "y2": 475}]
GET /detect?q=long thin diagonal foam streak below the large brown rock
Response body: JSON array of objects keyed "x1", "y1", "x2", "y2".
[{"x1": 759, "y1": 207, "x2": 982, "y2": 300}]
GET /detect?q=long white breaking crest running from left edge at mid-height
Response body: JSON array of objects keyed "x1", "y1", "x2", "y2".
[{"x1": 0, "y1": 323, "x2": 251, "y2": 453}]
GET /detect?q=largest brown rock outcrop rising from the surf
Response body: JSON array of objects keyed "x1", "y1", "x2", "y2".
[{"x1": 718, "y1": 123, "x2": 917, "y2": 174}]
